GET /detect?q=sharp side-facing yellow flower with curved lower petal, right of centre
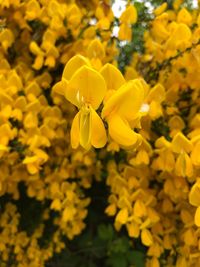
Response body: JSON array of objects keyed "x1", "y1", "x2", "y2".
[{"x1": 102, "y1": 79, "x2": 145, "y2": 147}]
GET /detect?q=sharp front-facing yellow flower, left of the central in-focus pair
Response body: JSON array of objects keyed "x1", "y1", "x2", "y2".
[{"x1": 55, "y1": 56, "x2": 107, "y2": 149}]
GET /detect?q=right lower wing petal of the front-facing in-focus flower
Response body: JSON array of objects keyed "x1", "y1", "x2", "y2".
[{"x1": 90, "y1": 108, "x2": 107, "y2": 148}]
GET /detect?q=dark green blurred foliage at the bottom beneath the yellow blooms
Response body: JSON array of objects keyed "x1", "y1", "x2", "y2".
[{"x1": 46, "y1": 224, "x2": 145, "y2": 267}]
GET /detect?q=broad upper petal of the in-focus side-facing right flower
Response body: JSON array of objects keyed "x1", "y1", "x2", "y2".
[{"x1": 102, "y1": 79, "x2": 145, "y2": 121}]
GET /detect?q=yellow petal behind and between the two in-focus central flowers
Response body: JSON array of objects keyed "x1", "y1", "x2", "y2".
[{"x1": 100, "y1": 63, "x2": 125, "y2": 90}]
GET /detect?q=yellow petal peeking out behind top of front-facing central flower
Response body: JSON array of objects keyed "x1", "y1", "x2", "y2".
[{"x1": 62, "y1": 55, "x2": 90, "y2": 80}]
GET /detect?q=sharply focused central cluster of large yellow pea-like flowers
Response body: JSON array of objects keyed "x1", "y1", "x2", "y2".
[{"x1": 53, "y1": 55, "x2": 147, "y2": 149}]
